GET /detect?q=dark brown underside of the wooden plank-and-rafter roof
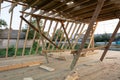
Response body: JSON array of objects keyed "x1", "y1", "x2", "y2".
[{"x1": 3, "y1": 0, "x2": 120, "y2": 22}]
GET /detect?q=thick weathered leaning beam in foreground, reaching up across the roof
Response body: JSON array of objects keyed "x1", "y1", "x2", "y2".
[{"x1": 70, "y1": 0, "x2": 105, "y2": 70}]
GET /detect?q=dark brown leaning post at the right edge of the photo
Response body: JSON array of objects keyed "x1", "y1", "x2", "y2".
[{"x1": 100, "y1": 19, "x2": 120, "y2": 61}]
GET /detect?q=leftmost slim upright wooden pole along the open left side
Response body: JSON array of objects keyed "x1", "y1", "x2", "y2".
[{"x1": 6, "y1": 11, "x2": 13, "y2": 58}]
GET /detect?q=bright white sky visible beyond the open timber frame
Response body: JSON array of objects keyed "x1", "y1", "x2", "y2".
[{"x1": 0, "y1": 2, "x2": 120, "y2": 34}]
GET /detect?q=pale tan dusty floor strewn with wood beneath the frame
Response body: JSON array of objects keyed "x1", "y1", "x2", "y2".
[{"x1": 0, "y1": 50, "x2": 120, "y2": 80}]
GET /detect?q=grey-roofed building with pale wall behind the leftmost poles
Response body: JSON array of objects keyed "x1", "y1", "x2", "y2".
[{"x1": 0, "y1": 29, "x2": 26, "y2": 49}]
